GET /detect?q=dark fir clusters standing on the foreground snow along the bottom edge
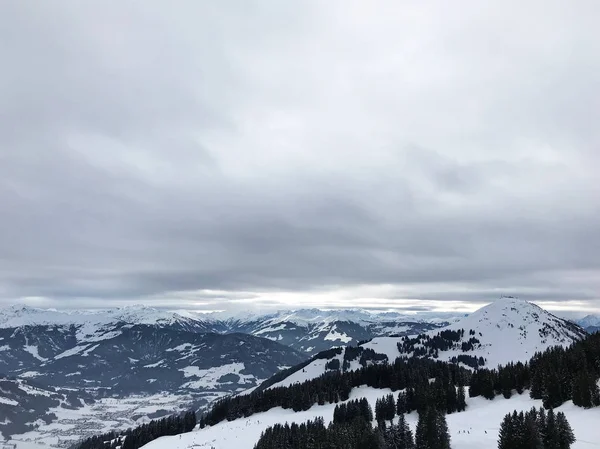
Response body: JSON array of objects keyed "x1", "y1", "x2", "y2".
[{"x1": 254, "y1": 393, "x2": 575, "y2": 449}]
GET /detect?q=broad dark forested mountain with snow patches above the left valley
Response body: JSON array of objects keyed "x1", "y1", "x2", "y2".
[{"x1": 0, "y1": 324, "x2": 303, "y2": 398}]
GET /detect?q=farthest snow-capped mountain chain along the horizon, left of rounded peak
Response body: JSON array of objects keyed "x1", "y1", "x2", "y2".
[{"x1": 0, "y1": 306, "x2": 456, "y2": 356}]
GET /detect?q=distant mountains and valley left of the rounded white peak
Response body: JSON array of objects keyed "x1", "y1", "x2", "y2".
[{"x1": 0, "y1": 300, "x2": 445, "y2": 439}]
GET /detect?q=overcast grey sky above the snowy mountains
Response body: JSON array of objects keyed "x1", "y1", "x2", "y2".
[{"x1": 0, "y1": 0, "x2": 600, "y2": 316}]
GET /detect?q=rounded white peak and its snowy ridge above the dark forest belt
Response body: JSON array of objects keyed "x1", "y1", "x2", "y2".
[{"x1": 267, "y1": 298, "x2": 586, "y2": 387}]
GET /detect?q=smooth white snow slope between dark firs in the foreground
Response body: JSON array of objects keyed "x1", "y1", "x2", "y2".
[{"x1": 139, "y1": 387, "x2": 600, "y2": 449}]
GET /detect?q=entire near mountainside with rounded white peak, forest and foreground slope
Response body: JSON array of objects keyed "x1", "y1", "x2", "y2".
[{"x1": 89, "y1": 298, "x2": 600, "y2": 449}]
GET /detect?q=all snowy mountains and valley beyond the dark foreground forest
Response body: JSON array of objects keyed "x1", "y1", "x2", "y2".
[{"x1": 0, "y1": 299, "x2": 585, "y2": 446}]
